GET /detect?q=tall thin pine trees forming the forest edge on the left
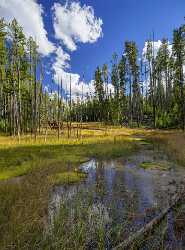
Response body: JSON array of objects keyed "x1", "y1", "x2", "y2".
[{"x1": 0, "y1": 19, "x2": 63, "y2": 138}]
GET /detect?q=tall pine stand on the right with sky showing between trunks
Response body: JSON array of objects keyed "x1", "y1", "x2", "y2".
[{"x1": 84, "y1": 28, "x2": 185, "y2": 130}]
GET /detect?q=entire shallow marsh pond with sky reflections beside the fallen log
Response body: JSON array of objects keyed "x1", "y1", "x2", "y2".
[{"x1": 49, "y1": 144, "x2": 185, "y2": 249}]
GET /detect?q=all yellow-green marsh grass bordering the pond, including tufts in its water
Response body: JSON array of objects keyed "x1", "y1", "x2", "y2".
[{"x1": 0, "y1": 124, "x2": 185, "y2": 250}]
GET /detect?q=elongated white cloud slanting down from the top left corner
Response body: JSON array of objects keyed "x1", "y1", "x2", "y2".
[{"x1": 0, "y1": 0, "x2": 55, "y2": 56}]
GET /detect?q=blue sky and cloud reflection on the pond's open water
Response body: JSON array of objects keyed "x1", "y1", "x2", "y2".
[{"x1": 81, "y1": 155, "x2": 171, "y2": 229}]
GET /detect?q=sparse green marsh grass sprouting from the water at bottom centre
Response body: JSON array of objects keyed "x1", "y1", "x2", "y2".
[{"x1": 43, "y1": 189, "x2": 111, "y2": 250}]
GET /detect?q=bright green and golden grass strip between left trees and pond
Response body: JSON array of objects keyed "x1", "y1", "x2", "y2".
[{"x1": 0, "y1": 124, "x2": 142, "y2": 180}]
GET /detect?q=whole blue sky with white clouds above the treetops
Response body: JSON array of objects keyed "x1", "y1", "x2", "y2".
[{"x1": 0, "y1": 0, "x2": 185, "y2": 94}]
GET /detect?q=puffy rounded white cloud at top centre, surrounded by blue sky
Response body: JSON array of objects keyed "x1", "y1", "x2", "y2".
[{"x1": 53, "y1": 2, "x2": 103, "y2": 51}]
